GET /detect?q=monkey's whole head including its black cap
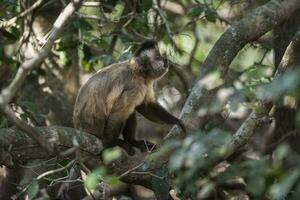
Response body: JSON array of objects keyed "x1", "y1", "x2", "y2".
[{"x1": 134, "y1": 40, "x2": 168, "y2": 79}]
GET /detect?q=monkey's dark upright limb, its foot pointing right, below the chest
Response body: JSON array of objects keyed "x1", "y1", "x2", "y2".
[{"x1": 123, "y1": 112, "x2": 154, "y2": 152}]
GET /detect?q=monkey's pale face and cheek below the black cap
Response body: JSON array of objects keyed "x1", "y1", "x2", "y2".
[{"x1": 139, "y1": 49, "x2": 168, "y2": 79}]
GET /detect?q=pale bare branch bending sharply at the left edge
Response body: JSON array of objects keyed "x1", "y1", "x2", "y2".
[{"x1": 0, "y1": 0, "x2": 82, "y2": 151}]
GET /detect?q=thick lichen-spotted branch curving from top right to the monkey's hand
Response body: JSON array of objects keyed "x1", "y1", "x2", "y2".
[{"x1": 142, "y1": 0, "x2": 300, "y2": 168}]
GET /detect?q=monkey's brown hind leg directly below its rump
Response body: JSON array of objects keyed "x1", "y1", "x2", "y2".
[{"x1": 102, "y1": 114, "x2": 135, "y2": 155}]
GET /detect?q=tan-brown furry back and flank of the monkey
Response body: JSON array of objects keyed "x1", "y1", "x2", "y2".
[{"x1": 73, "y1": 62, "x2": 148, "y2": 138}]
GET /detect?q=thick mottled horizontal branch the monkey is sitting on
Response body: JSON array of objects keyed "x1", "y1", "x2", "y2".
[{"x1": 0, "y1": 126, "x2": 151, "y2": 188}]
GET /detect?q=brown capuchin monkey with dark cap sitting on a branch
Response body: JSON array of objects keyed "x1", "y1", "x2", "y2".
[{"x1": 73, "y1": 40, "x2": 185, "y2": 155}]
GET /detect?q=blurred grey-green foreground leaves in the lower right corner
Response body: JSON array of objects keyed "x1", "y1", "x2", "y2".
[{"x1": 169, "y1": 130, "x2": 300, "y2": 199}]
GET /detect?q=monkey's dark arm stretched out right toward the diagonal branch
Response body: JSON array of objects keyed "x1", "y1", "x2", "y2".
[{"x1": 136, "y1": 102, "x2": 186, "y2": 132}]
